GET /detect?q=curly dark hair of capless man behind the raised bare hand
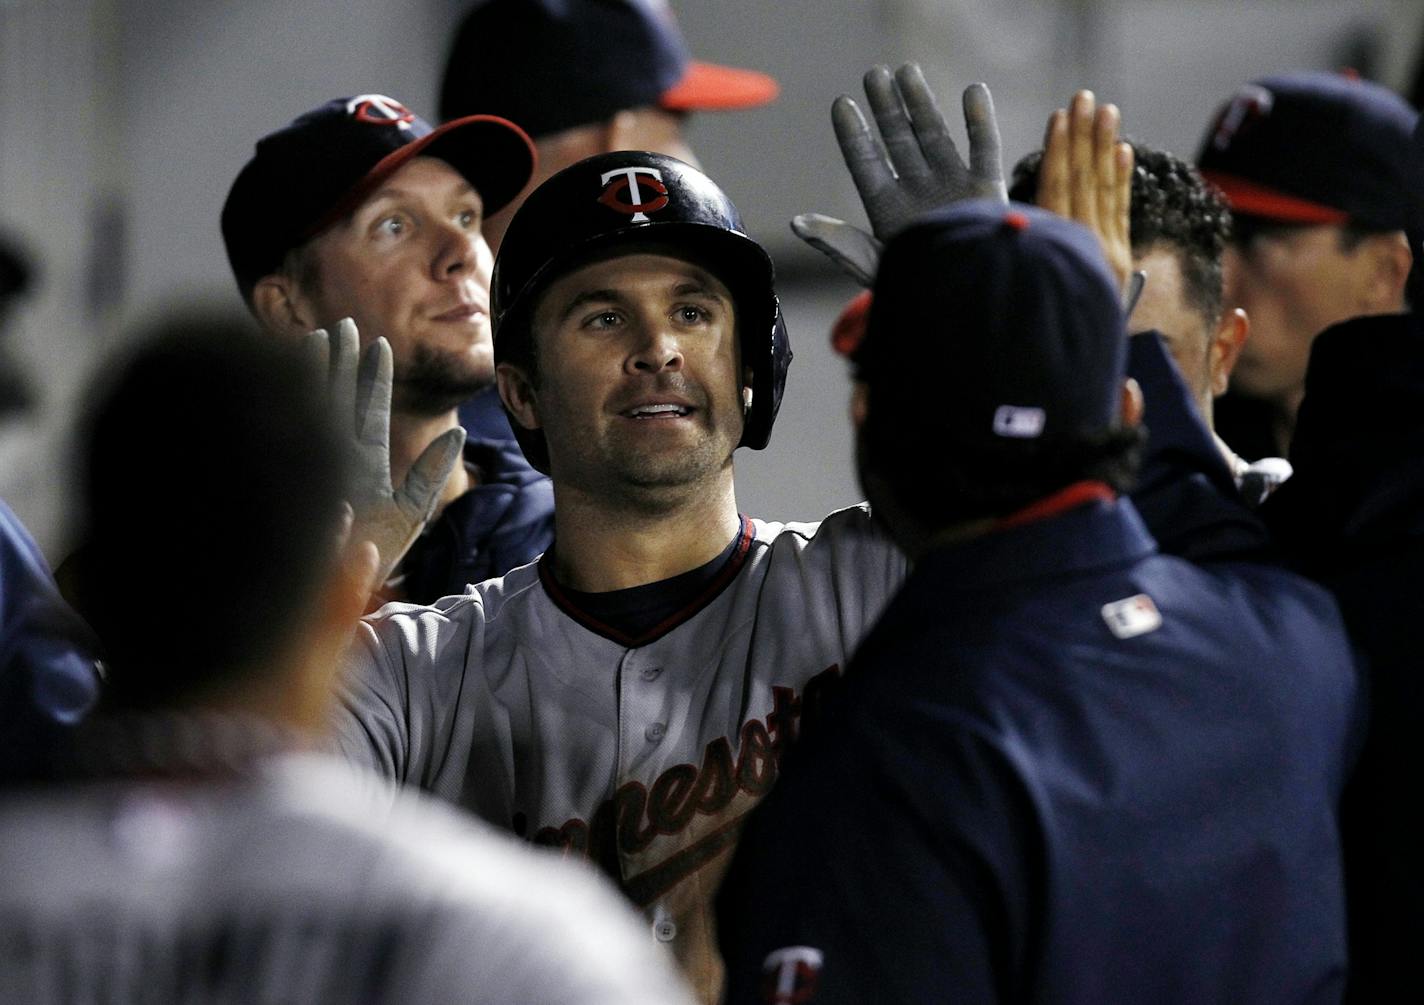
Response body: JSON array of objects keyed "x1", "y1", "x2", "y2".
[{"x1": 1008, "y1": 141, "x2": 1232, "y2": 323}]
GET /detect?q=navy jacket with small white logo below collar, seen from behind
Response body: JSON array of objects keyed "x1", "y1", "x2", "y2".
[{"x1": 718, "y1": 501, "x2": 1357, "y2": 1005}]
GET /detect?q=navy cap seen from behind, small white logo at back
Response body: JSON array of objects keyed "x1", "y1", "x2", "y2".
[{"x1": 852, "y1": 199, "x2": 1128, "y2": 456}]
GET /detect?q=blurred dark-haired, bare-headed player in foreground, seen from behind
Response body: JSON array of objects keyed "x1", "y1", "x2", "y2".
[{"x1": 0, "y1": 319, "x2": 691, "y2": 1005}]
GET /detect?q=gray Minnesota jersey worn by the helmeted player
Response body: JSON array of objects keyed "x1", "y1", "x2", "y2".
[{"x1": 337, "y1": 507, "x2": 907, "y2": 1001}]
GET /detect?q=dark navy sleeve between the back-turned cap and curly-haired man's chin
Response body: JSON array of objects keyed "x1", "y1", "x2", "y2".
[{"x1": 1128, "y1": 332, "x2": 1272, "y2": 561}]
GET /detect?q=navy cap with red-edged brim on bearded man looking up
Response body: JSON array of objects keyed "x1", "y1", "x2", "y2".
[{"x1": 222, "y1": 94, "x2": 534, "y2": 300}]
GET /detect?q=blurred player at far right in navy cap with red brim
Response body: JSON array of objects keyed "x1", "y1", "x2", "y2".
[{"x1": 1196, "y1": 73, "x2": 1417, "y2": 457}]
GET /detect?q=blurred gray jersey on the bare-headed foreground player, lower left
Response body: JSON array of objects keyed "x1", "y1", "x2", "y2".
[{"x1": 0, "y1": 754, "x2": 691, "y2": 1005}]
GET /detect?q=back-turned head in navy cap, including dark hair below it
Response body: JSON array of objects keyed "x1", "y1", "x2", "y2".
[{"x1": 853, "y1": 202, "x2": 1139, "y2": 531}]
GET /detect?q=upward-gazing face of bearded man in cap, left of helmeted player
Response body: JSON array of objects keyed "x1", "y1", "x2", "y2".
[{"x1": 291, "y1": 157, "x2": 494, "y2": 413}]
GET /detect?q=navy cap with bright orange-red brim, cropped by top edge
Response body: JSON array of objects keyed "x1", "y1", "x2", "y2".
[{"x1": 440, "y1": 0, "x2": 780, "y2": 137}]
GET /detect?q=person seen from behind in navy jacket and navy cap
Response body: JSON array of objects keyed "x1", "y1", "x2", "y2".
[{"x1": 718, "y1": 201, "x2": 1358, "y2": 1005}]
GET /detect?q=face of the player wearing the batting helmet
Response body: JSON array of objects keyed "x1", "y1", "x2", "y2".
[{"x1": 521, "y1": 253, "x2": 743, "y2": 491}]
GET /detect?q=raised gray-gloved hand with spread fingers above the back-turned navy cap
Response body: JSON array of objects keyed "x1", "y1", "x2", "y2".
[{"x1": 792, "y1": 63, "x2": 1008, "y2": 286}]
